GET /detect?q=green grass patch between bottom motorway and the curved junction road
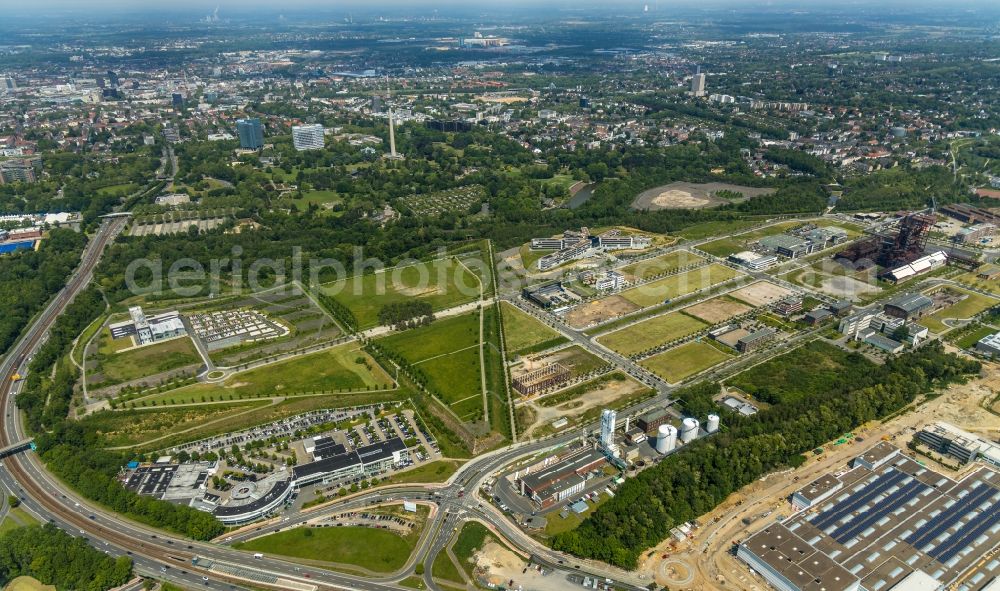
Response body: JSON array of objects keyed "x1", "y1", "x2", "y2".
[{"x1": 234, "y1": 527, "x2": 419, "y2": 573}]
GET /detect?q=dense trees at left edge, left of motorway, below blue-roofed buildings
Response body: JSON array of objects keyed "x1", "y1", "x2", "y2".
[{"x1": 0, "y1": 228, "x2": 87, "y2": 354}]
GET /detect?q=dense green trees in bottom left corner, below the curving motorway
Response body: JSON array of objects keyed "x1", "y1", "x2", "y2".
[{"x1": 0, "y1": 524, "x2": 132, "y2": 591}]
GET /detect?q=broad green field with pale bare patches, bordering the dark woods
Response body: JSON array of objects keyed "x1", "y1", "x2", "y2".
[{"x1": 323, "y1": 258, "x2": 480, "y2": 328}]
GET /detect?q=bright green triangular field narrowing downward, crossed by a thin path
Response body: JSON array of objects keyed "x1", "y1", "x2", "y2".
[{"x1": 379, "y1": 313, "x2": 483, "y2": 419}]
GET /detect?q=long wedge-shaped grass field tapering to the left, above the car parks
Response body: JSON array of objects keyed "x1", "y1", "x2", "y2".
[{"x1": 137, "y1": 343, "x2": 392, "y2": 405}]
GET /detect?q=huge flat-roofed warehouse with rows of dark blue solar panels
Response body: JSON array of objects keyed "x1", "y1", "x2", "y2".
[{"x1": 737, "y1": 446, "x2": 1000, "y2": 591}]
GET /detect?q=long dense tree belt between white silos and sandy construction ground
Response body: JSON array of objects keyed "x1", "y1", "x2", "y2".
[{"x1": 552, "y1": 343, "x2": 979, "y2": 569}]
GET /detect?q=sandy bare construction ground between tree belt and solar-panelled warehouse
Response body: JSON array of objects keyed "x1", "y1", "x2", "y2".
[{"x1": 639, "y1": 363, "x2": 1000, "y2": 591}]
